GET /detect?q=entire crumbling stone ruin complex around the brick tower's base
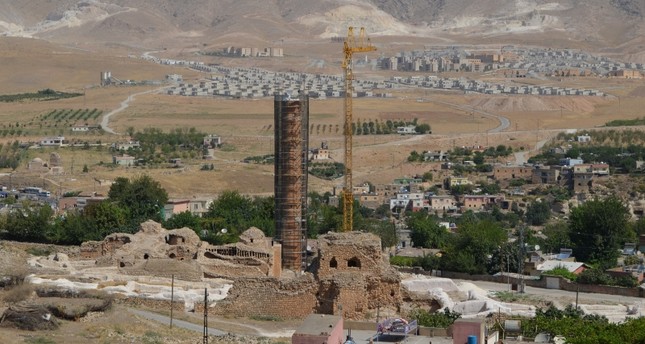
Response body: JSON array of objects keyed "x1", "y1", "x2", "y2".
[{"x1": 80, "y1": 221, "x2": 402, "y2": 319}]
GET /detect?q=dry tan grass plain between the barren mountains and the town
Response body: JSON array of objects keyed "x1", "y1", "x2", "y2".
[{"x1": 0, "y1": 38, "x2": 645, "y2": 198}]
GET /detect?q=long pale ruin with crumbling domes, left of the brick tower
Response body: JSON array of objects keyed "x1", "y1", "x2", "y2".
[{"x1": 80, "y1": 221, "x2": 281, "y2": 281}]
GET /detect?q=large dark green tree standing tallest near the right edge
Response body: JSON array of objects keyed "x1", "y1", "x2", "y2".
[{"x1": 569, "y1": 195, "x2": 630, "y2": 267}]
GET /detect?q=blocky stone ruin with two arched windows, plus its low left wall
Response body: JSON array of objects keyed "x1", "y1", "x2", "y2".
[{"x1": 215, "y1": 232, "x2": 402, "y2": 319}]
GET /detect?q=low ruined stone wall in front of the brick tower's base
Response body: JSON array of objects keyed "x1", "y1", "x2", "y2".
[{"x1": 213, "y1": 274, "x2": 318, "y2": 319}]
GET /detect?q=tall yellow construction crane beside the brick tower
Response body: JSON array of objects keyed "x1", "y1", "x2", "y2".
[{"x1": 343, "y1": 26, "x2": 376, "y2": 232}]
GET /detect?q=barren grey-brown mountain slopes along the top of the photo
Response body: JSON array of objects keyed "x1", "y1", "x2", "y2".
[{"x1": 0, "y1": 0, "x2": 645, "y2": 54}]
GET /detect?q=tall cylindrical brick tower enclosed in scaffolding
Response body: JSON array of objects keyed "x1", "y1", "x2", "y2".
[{"x1": 274, "y1": 94, "x2": 309, "y2": 271}]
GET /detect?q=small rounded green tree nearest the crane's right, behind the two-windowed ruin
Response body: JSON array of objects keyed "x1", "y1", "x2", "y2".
[{"x1": 407, "y1": 212, "x2": 449, "y2": 248}]
